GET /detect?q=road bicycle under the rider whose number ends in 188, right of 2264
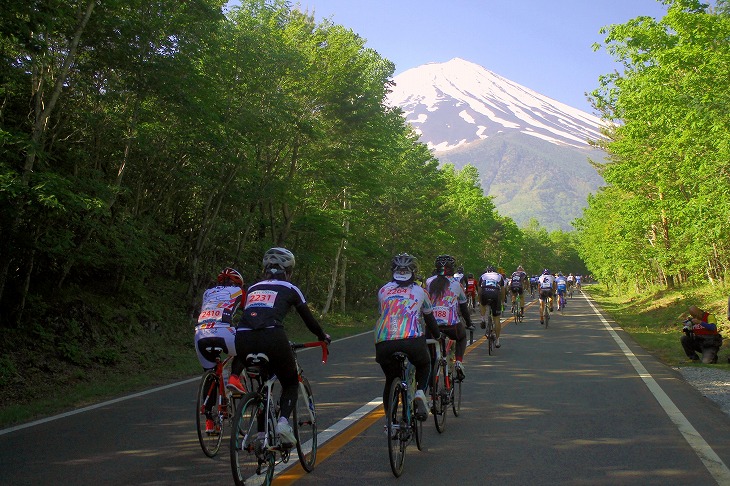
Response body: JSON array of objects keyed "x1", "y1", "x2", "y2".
[{"x1": 426, "y1": 336, "x2": 462, "y2": 433}]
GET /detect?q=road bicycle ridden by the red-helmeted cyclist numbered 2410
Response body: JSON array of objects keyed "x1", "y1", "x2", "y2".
[{"x1": 195, "y1": 347, "x2": 241, "y2": 457}]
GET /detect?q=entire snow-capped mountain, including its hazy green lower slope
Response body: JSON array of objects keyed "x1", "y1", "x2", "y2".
[{"x1": 389, "y1": 58, "x2": 605, "y2": 231}]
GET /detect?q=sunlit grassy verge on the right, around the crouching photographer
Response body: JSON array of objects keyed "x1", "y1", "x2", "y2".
[{"x1": 585, "y1": 284, "x2": 730, "y2": 370}]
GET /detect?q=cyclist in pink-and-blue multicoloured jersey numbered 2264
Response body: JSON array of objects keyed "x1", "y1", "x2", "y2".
[{"x1": 375, "y1": 253, "x2": 440, "y2": 420}]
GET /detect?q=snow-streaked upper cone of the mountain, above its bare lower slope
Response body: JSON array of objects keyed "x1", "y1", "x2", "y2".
[{"x1": 388, "y1": 58, "x2": 602, "y2": 152}]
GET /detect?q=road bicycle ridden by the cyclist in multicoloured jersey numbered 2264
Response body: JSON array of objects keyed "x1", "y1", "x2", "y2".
[{"x1": 386, "y1": 351, "x2": 424, "y2": 477}]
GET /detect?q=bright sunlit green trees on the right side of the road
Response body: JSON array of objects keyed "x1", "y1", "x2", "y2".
[{"x1": 578, "y1": 0, "x2": 730, "y2": 286}]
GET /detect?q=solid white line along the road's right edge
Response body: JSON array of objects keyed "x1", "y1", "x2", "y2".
[{"x1": 581, "y1": 292, "x2": 730, "y2": 484}]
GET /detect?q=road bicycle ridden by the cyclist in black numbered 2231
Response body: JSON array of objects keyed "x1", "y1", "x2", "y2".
[{"x1": 230, "y1": 341, "x2": 328, "y2": 486}]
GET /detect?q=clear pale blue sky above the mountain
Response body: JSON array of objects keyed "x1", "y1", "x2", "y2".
[{"x1": 280, "y1": 0, "x2": 666, "y2": 113}]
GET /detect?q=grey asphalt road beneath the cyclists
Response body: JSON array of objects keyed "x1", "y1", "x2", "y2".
[{"x1": 0, "y1": 295, "x2": 730, "y2": 485}]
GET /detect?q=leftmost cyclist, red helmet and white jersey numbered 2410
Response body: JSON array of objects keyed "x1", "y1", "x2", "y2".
[{"x1": 195, "y1": 267, "x2": 246, "y2": 434}]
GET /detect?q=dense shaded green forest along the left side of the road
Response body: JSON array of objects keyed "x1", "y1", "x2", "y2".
[{"x1": 0, "y1": 0, "x2": 585, "y2": 385}]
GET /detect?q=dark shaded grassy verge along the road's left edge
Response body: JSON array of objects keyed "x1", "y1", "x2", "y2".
[{"x1": 0, "y1": 312, "x2": 375, "y2": 429}]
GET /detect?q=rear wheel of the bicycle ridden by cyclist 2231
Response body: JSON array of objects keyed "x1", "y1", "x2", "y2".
[{"x1": 230, "y1": 393, "x2": 274, "y2": 486}]
